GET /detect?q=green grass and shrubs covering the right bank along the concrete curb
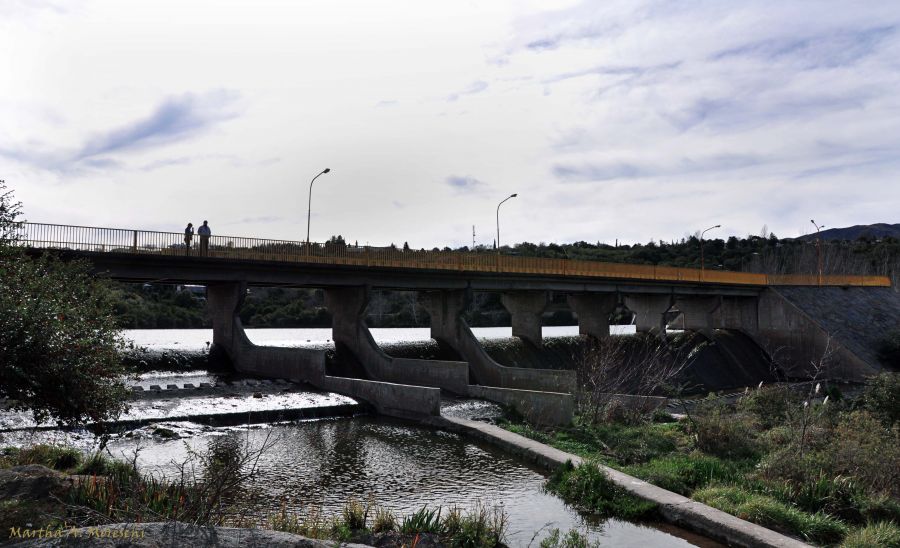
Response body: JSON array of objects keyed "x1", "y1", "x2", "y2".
[{"x1": 502, "y1": 373, "x2": 900, "y2": 546}]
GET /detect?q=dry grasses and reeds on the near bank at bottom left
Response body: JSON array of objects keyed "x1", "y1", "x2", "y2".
[{"x1": 0, "y1": 435, "x2": 507, "y2": 548}]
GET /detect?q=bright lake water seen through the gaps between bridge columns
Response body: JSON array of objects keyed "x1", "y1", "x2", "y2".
[{"x1": 123, "y1": 325, "x2": 634, "y2": 350}]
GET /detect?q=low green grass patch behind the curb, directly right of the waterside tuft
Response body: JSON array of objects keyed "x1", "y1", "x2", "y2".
[{"x1": 624, "y1": 452, "x2": 750, "y2": 496}]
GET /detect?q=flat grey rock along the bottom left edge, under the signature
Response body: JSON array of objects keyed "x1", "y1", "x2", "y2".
[{"x1": 11, "y1": 522, "x2": 368, "y2": 548}]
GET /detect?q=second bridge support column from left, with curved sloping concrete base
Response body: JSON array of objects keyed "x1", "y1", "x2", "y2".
[{"x1": 325, "y1": 287, "x2": 469, "y2": 395}]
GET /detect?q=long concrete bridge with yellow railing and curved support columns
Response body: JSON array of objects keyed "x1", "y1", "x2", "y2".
[{"x1": 18, "y1": 223, "x2": 900, "y2": 423}]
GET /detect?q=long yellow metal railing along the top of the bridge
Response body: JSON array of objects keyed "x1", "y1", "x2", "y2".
[{"x1": 16, "y1": 223, "x2": 891, "y2": 287}]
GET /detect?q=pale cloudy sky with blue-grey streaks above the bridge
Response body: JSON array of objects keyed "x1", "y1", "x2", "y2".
[{"x1": 0, "y1": 0, "x2": 900, "y2": 248}]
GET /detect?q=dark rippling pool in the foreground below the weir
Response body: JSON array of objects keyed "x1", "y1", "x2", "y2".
[{"x1": 103, "y1": 417, "x2": 715, "y2": 548}]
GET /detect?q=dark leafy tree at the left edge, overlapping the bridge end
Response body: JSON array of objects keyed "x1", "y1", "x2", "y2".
[{"x1": 0, "y1": 182, "x2": 128, "y2": 431}]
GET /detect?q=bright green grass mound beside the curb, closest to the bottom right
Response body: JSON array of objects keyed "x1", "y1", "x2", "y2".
[{"x1": 692, "y1": 487, "x2": 848, "y2": 543}]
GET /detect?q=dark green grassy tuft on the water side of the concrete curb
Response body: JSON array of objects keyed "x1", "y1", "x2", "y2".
[{"x1": 547, "y1": 461, "x2": 656, "y2": 520}]
